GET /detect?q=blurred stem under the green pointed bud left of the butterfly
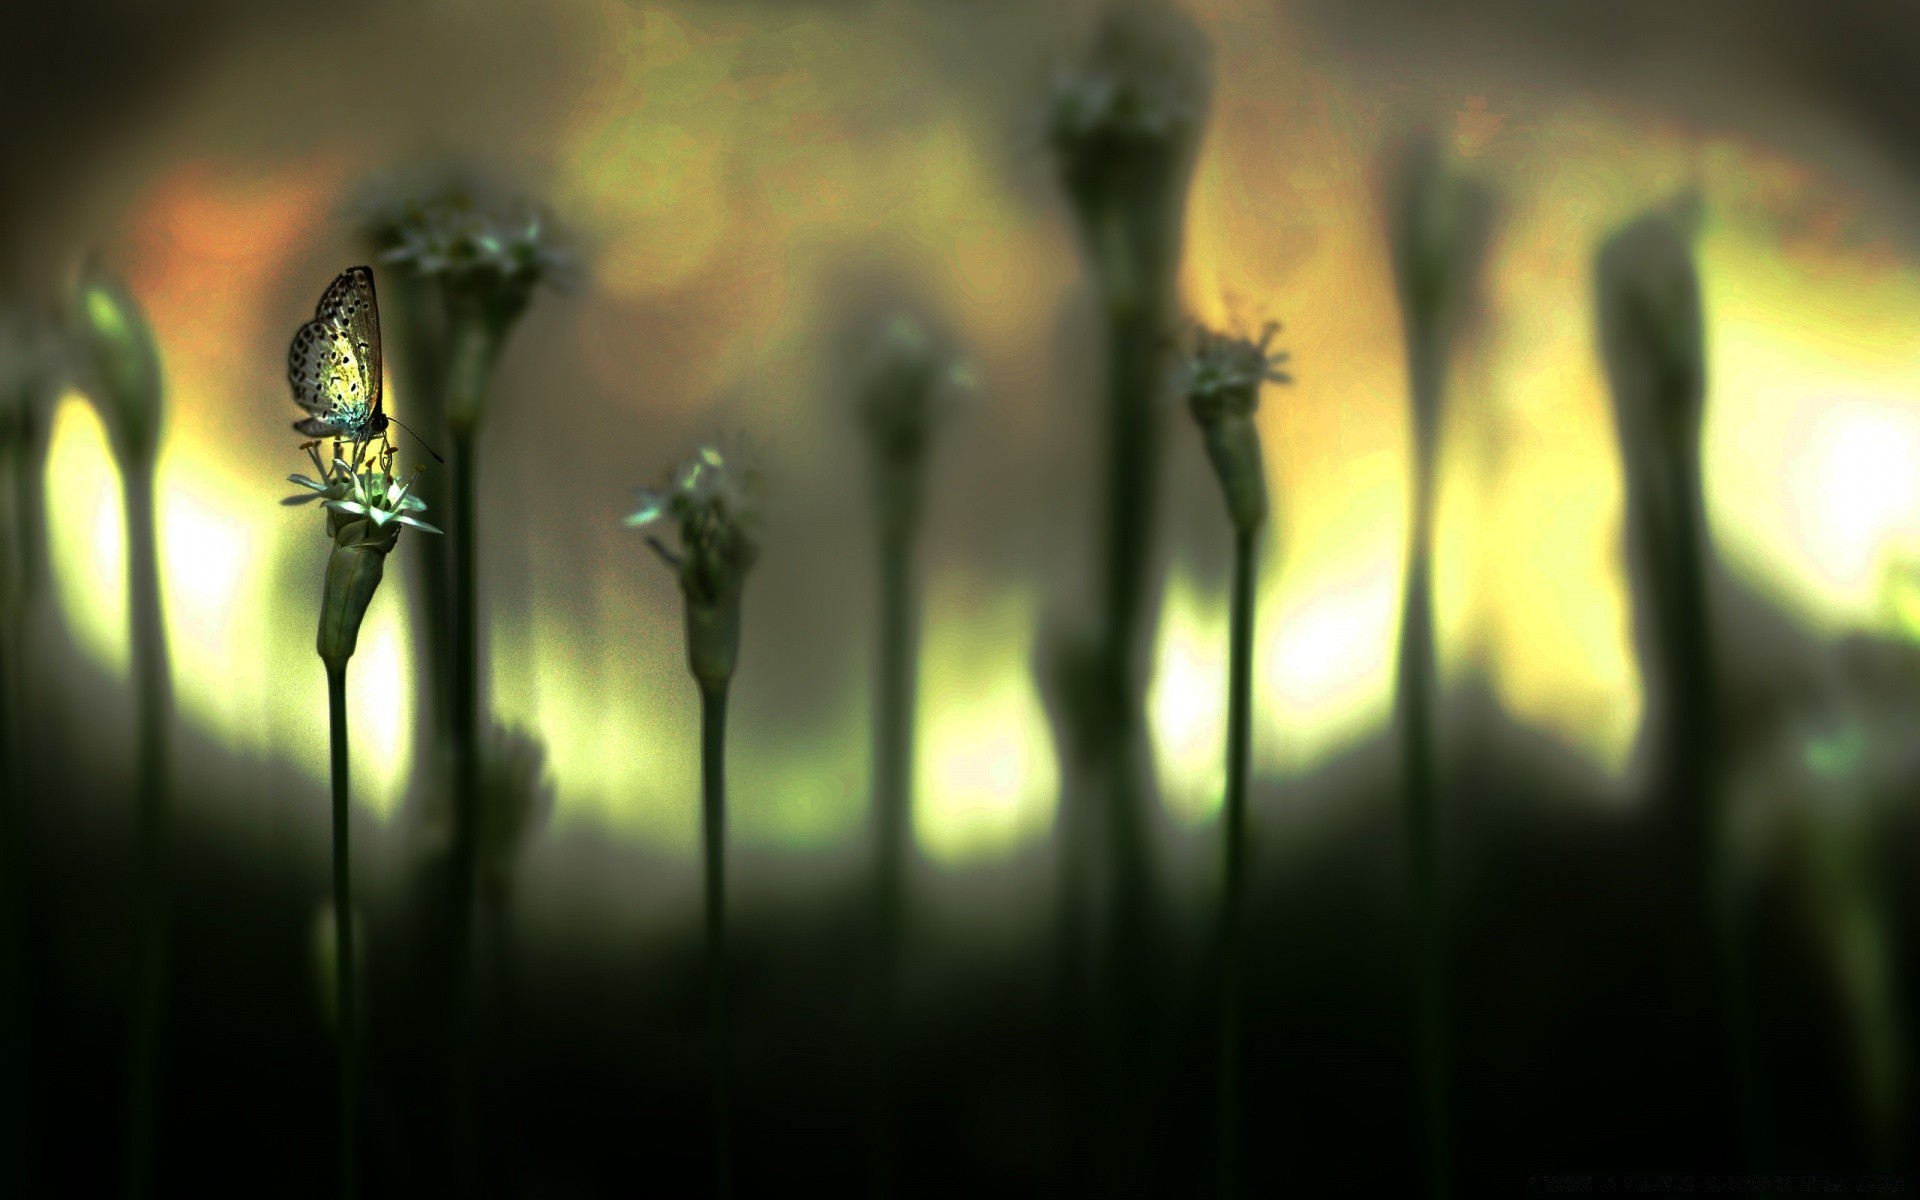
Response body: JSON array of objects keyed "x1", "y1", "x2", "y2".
[{"x1": 121, "y1": 453, "x2": 171, "y2": 1196}]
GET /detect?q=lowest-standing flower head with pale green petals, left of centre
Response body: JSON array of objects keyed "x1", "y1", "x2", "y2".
[{"x1": 624, "y1": 444, "x2": 760, "y2": 685}]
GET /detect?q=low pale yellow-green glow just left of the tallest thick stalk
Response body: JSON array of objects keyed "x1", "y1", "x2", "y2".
[{"x1": 914, "y1": 578, "x2": 1058, "y2": 866}]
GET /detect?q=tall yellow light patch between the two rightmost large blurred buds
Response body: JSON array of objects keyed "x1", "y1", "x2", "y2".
[{"x1": 1459, "y1": 159, "x2": 1659, "y2": 774}]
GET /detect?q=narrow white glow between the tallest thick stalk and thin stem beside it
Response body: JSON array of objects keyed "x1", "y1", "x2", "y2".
[{"x1": 1146, "y1": 570, "x2": 1227, "y2": 824}]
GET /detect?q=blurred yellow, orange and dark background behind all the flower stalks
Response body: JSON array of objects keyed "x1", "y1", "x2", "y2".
[{"x1": 0, "y1": 0, "x2": 1920, "y2": 1196}]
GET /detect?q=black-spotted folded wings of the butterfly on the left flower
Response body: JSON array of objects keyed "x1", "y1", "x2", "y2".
[{"x1": 286, "y1": 267, "x2": 386, "y2": 442}]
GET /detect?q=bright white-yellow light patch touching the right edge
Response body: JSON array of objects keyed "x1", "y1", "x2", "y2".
[{"x1": 1703, "y1": 228, "x2": 1920, "y2": 632}]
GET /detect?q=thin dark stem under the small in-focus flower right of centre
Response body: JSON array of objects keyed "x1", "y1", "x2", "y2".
[{"x1": 1219, "y1": 528, "x2": 1260, "y2": 1196}]
